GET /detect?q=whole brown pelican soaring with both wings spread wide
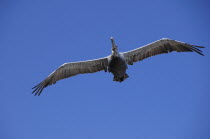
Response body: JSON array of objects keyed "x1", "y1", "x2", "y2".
[{"x1": 32, "y1": 37, "x2": 204, "y2": 95}]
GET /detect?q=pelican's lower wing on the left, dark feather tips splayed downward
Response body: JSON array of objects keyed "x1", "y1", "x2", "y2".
[{"x1": 32, "y1": 57, "x2": 108, "y2": 95}]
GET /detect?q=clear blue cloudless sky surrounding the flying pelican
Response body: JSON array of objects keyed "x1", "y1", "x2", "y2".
[{"x1": 0, "y1": 0, "x2": 210, "y2": 139}]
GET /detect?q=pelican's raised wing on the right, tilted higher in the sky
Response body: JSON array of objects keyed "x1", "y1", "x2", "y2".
[{"x1": 122, "y1": 39, "x2": 204, "y2": 65}]
